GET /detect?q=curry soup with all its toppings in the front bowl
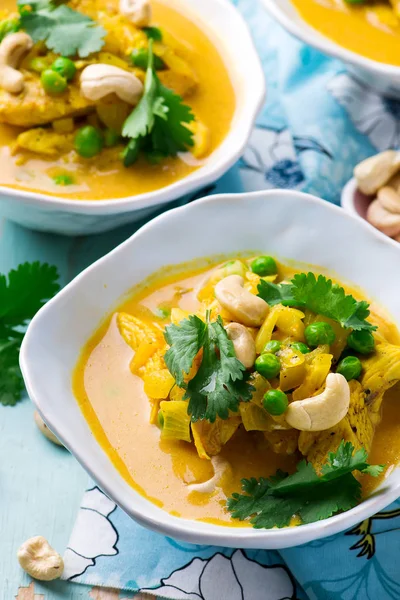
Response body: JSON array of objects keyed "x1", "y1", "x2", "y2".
[{"x1": 73, "y1": 256, "x2": 400, "y2": 527}]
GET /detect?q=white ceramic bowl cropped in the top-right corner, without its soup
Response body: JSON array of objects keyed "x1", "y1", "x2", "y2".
[{"x1": 262, "y1": 0, "x2": 400, "y2": 97}]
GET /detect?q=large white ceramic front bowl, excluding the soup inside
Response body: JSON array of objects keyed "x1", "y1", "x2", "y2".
[{"x1": 21, "y1": 190, "x2": 400, "y2": 548}]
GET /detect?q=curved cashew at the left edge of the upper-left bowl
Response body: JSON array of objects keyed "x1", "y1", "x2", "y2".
[{"x1": 0, "y1": 31, "x2": 33, "y2": 94}]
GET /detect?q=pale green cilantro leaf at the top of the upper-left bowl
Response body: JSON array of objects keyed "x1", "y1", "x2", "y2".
[{"x1": 18, "y1": 0, "x2": 106, "y2": 58}]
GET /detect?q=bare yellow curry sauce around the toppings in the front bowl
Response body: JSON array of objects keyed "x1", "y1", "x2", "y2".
[{"x1": 73, "y1": 258, "x2": 400, "y2": 527}]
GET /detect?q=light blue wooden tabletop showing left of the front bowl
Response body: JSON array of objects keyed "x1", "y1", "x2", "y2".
[{"x1": 0, "y1": 220, "x2": 148, "y2": 600}]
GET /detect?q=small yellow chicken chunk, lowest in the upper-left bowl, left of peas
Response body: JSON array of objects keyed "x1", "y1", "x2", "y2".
[{"x1": 12, "y1": 127, "x2": 74, "y2": 156}]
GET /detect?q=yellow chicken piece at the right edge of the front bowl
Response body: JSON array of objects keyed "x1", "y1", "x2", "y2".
[{"x1": 360, "y1": 342, "x2": 400, "y2": 406}]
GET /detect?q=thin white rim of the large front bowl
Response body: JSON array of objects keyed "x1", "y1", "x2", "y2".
[{"x1": 20, "y1": 190, "x2": 400, "y2": 549}]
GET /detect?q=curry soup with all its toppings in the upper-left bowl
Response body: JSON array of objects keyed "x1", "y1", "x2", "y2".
[{"x1": 0, "y1": 0, "x2": 235, "y2": 200}]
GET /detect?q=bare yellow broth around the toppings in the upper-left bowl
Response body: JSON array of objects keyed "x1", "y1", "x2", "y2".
[{"x1": 0, "y1": 0, "x2": 236, "y2": 200}]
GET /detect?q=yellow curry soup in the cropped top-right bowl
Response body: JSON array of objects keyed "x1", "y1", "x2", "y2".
[{"x1": 291, "y1": 0, "x2": 400, "y2": 66}]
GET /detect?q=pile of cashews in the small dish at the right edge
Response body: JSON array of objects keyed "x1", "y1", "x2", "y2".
[{"x1": 354, "y1": 150, "x2": 400, "y2": 242}]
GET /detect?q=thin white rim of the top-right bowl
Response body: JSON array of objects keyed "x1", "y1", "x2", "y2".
[{"x1": 261, "y1": 0, "x2": 400, "y2": 78}]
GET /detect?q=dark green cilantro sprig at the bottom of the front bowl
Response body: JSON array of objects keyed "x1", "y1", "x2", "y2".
[{"x1": 227, "y1": 440, "x2": 384, "y2": 529}]
